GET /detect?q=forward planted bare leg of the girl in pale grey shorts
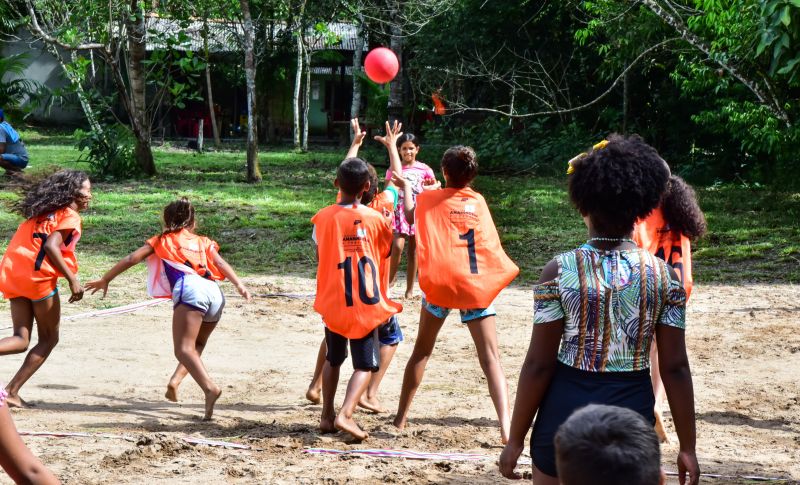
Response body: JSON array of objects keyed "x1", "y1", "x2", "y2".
[{"x1": 172, "y1": 305, "x2": 222, "y2": 420}]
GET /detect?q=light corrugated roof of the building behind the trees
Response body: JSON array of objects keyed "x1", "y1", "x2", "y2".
[{"x1": 146, "y1": 16, "x2": 367, "y2": 53}]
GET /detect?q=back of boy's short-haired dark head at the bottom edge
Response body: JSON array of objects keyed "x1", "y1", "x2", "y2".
[{"x1": 555, "y1": 404, "x2": 664, "y2": 485}]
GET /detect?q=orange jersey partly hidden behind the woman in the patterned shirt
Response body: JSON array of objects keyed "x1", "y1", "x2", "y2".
[{"x1": 633, "y1": 207, "x2": 693, "y2": 298}]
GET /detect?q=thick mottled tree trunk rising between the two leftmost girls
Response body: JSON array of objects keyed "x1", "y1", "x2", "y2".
[{"x1": 126, "y1": 0, "x2": 156, "y2": 175}]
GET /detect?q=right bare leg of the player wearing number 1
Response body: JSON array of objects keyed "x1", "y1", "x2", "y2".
[{"x1": 467, "y1": 316, "x2": 511, "y2": 444}]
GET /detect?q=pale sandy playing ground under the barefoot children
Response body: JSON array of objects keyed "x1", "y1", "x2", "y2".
[{"x1": 0, "y1": 276, "x2": 800, "y2": 484}]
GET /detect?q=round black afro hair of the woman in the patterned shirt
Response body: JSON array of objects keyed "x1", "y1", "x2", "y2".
[{"x1": 569, "y1": 134, "x2": 670, "y2": 237}]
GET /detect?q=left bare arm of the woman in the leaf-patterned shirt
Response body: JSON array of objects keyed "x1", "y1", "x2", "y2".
[{"x1": 500, "y1": 261, "x2": 564, "y2": 479}]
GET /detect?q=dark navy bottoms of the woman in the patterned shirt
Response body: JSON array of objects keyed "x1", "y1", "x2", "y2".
[{"x1": 531, "y1": 362, "x2": 656, "y2": 477}]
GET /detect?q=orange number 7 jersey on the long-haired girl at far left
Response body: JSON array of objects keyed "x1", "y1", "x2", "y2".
[{"x1": 0, "y1": 207, "x2": 82, "y2": 300}]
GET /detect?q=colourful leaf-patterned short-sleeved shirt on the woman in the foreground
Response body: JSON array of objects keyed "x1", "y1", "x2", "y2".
[{"x1": 533, "y1": 244, "x2": 686, "y2": 372}]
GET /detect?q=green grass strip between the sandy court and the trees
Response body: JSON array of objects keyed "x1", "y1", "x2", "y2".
[{"x1": 0, "y1": 135, "x2": 800, "y2": 292}]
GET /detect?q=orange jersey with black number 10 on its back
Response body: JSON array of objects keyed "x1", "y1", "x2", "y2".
[{"x1": 311, "y1": 205, "x2": 403, "y2": 338}]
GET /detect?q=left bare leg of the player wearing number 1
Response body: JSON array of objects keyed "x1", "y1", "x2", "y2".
[{"x1": 394, "y1": 308, "x2": 444, "y2": 429}]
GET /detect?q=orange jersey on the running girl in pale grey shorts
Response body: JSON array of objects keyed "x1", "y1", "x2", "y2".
[{"x1": 147, "y1": 229, "x2": 225, "y2": 298}]
